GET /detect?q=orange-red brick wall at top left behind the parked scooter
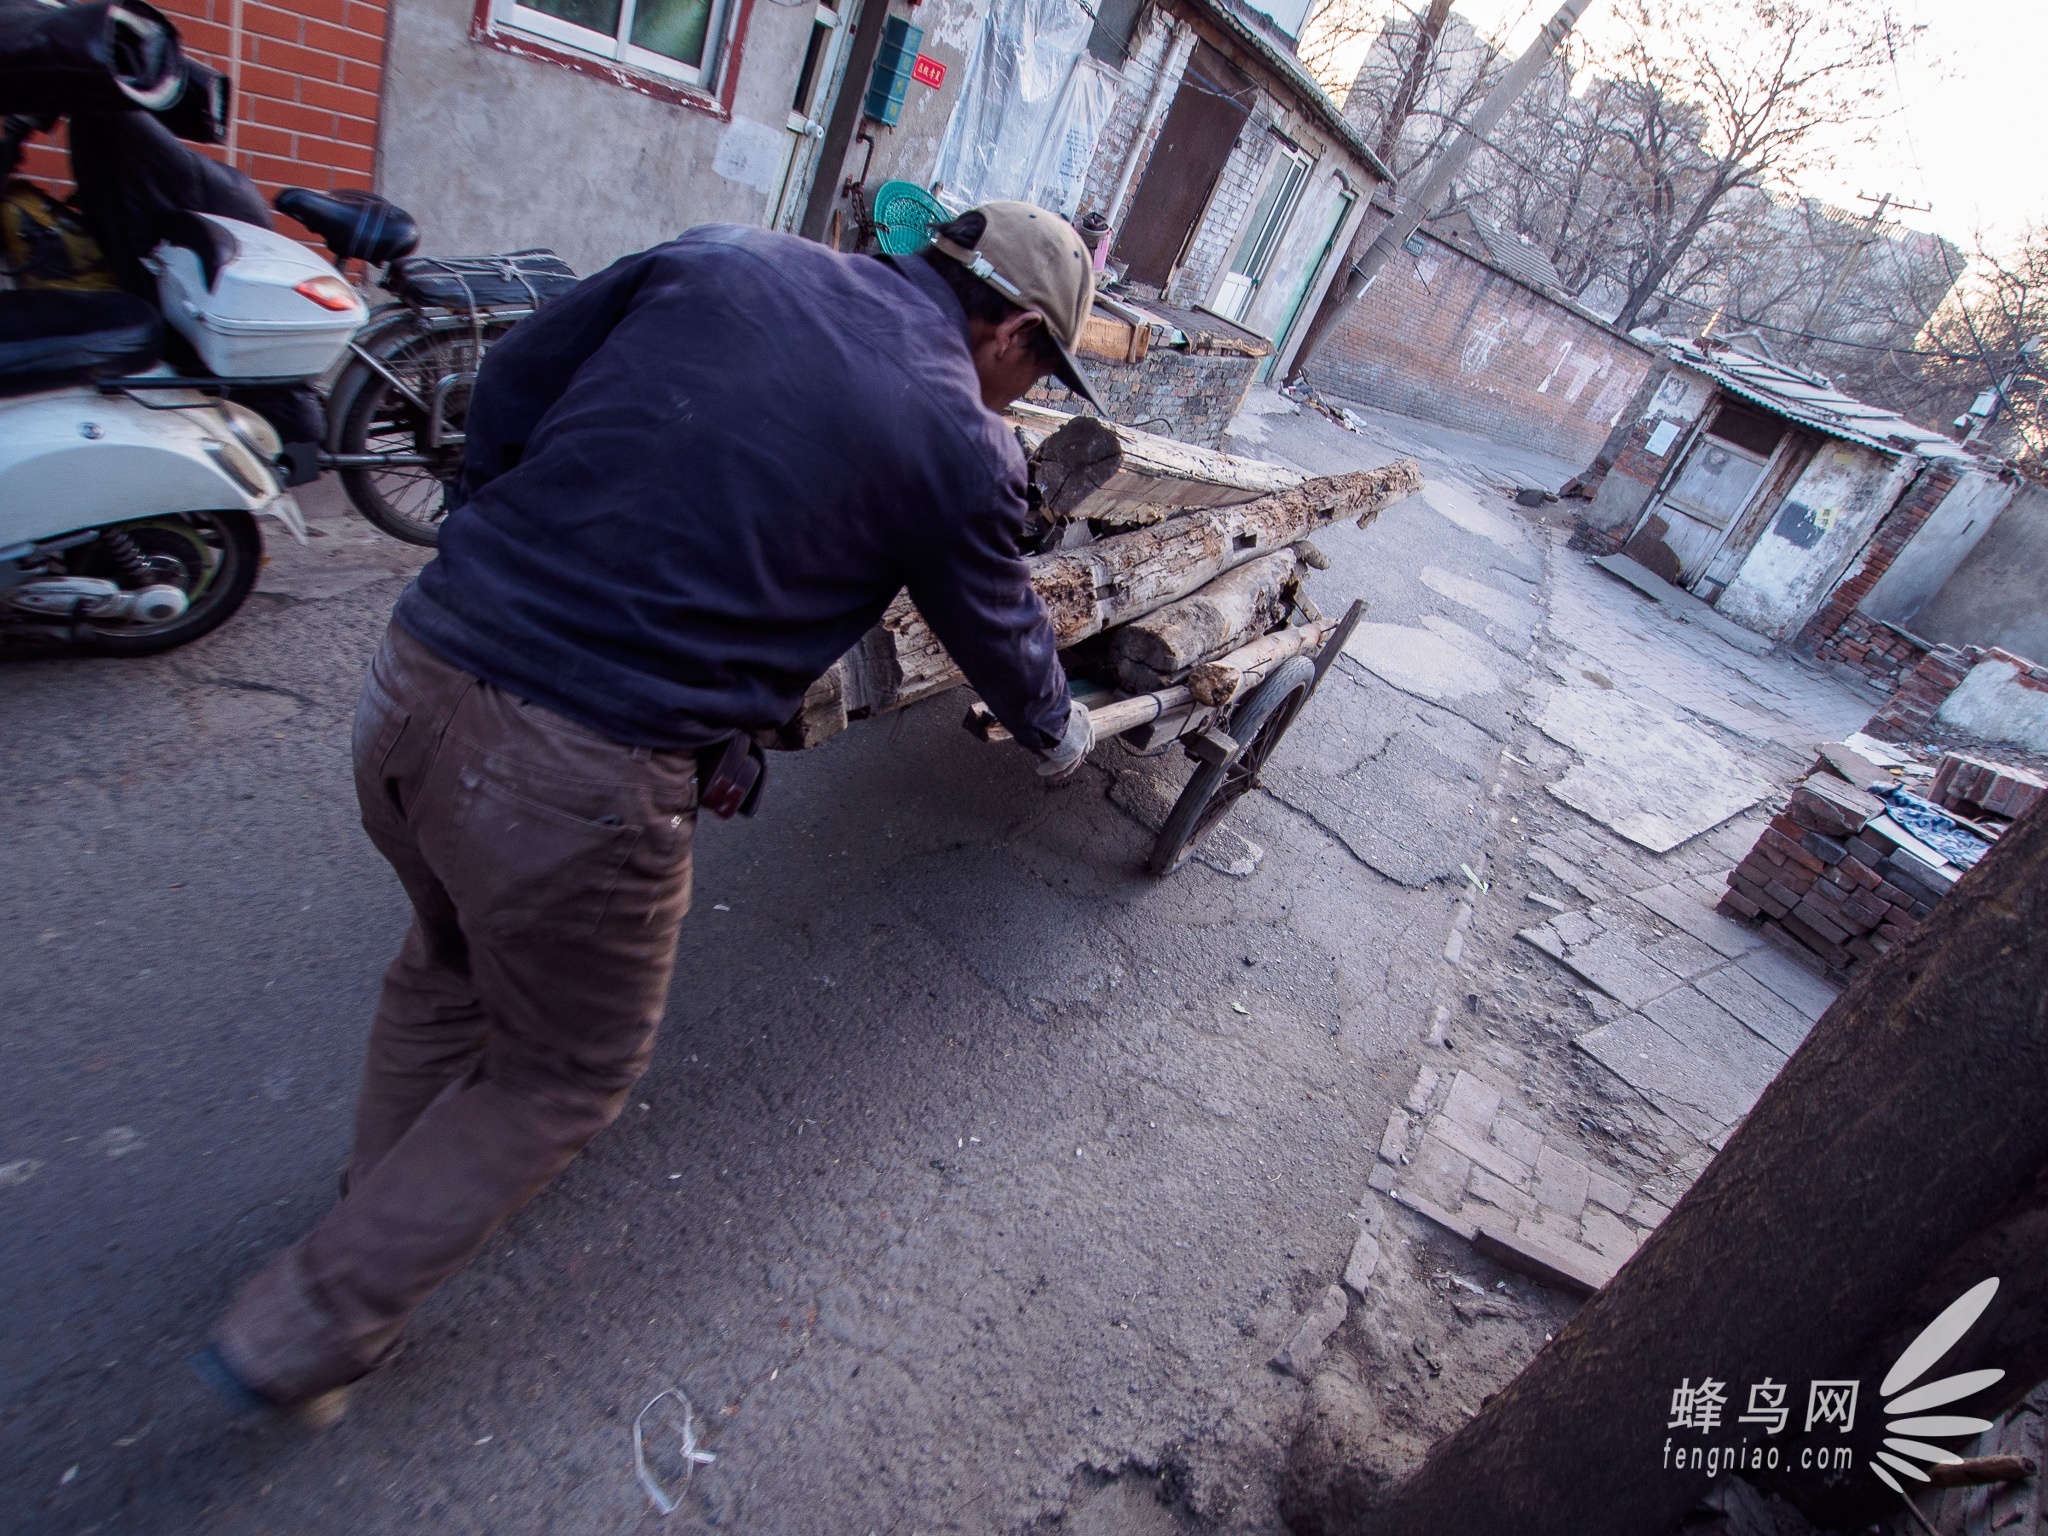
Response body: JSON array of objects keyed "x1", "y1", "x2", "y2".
[{"x1": 23, "y1": 0, "x2": 389, "y2": 236}]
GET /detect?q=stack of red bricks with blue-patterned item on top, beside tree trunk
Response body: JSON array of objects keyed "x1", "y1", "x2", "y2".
[{"x1": 1720, "y1": 774, "x2": 1954, "y2": 971}]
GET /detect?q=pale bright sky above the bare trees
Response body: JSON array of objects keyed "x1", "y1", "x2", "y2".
[{"x1": 1335, "y1": 0, "x2": 2048, "y2": 262}]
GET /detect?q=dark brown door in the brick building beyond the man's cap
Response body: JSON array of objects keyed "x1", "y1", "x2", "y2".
[{"x1": 1110, "y1": 43, "x2": 1255, "y2": 289}]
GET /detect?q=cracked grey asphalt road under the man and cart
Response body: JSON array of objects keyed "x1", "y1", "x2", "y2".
[{"x1": 0, "y1": 418, "x2": 1542, "y2": 1536}]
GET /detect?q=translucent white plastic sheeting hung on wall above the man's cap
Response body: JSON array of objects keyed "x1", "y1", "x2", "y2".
[{"x1": 936, "y1": 0, "x2": 1116, "y2": 219}]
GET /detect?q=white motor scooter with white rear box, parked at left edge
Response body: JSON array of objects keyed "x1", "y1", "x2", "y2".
[{"x1": 0, "y1": 213, "x2": 344, "y2": 655}]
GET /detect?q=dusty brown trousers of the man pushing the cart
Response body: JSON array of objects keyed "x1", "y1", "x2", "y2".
[{"x1": 215, "y1": 627, "x2": 696, "y2": 1403}]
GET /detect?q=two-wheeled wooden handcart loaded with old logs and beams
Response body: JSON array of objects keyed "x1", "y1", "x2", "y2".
[{"x1": 762, "y1": 406, "x2": 1421, "y2": 874}]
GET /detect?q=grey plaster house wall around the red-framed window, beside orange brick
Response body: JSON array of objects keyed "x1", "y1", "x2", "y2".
[{"x1": 377, "y1": 0, "x2": 823, "y2": 272}]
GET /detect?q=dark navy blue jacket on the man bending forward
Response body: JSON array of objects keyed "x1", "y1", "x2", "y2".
[{"x1": 395, "y1": 225, "x2": 1067, "y2": 748}]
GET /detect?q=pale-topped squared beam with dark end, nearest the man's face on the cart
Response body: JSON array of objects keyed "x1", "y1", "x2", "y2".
[{"x1": 1012, "y1": 408, "x2": 1307, "y2": 528}]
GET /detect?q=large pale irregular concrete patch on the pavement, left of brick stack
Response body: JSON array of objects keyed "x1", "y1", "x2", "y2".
[{"x1": 1536, "y1": 686, "x2": 1772, "y2": 854}]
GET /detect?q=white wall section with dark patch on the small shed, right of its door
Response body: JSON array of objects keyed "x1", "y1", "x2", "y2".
[{"x1": 1714, "y1": 442, "x2": 1921, "y2": 639}]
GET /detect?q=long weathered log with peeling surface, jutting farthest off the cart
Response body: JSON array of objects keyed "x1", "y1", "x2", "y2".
[{"x1": 776, "y1": 459, "x2": 1421, "y2": 745}]
